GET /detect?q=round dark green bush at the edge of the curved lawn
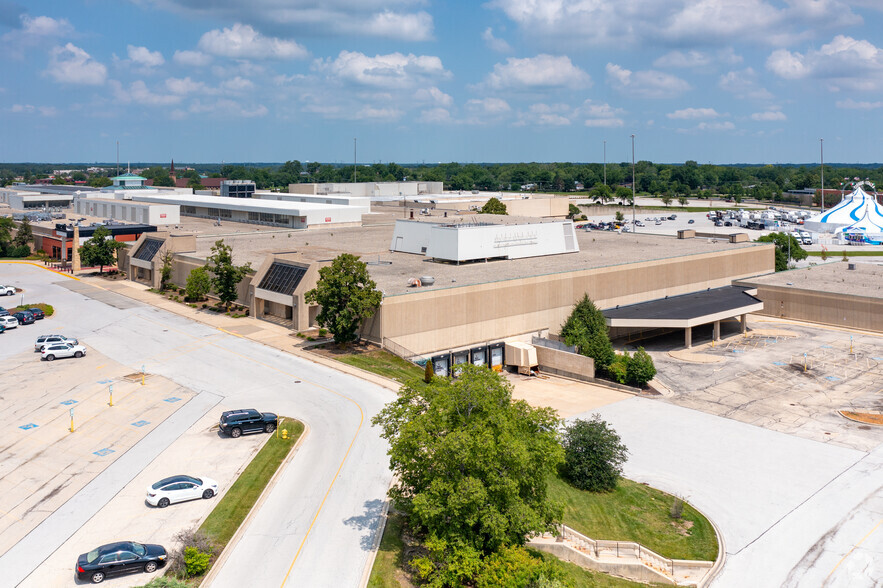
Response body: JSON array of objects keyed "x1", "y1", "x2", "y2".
[{"x1": 561, "y1": 414, "x2": 628, "y2": 492}]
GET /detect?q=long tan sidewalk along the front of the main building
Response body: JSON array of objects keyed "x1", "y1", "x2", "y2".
[{"x1": 79, "y1": 276, "x2": 400, "y2": 392}]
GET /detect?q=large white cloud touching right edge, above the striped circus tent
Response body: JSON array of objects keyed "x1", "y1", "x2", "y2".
[{"x1": 766, "y1": 35, "x2": 883, "y2": 90}]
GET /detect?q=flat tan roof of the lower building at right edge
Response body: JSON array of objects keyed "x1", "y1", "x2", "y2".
[{"x1": 740, "y1": 260, "x2": 883, "y2": 298}]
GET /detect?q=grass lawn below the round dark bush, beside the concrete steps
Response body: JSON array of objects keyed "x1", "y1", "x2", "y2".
[{"x1": 549, "y1": 477, "x2": 717, "y2": 561}]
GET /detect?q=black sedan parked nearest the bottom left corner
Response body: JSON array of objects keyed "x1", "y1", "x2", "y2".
[{"x1": 77, "y1": 541, "x2": 167, "y2": 584}]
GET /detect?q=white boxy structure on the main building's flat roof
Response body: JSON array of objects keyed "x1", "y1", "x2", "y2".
[{"x1": 389, "y1": 215, "x2": 579, "y2": 263}]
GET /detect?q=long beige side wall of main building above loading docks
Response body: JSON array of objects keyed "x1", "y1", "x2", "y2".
[{"x1": 380, "y1": 245, "x2": 774, "y2": 354}]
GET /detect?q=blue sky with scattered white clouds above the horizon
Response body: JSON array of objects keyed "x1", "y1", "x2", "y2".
[{"x1": 0, "y1": 0, "x2": 883, "y2": 163}]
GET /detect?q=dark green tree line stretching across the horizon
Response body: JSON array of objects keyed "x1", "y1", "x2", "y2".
[{"x1": 0, "y1": 160, "x2": 883, "y2": 201}]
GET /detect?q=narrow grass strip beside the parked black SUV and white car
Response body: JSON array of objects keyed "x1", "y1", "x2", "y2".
[{"x1": 199, "y1": 418, "x2": 304, "y2": 549}]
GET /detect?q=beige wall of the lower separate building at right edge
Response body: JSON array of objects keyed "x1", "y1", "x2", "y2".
[{"x1": 738, "y1": 280, "x2": 883, "y2": 332}]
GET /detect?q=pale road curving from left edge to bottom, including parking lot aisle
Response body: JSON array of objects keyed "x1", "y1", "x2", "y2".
[{"x1": 0, "y1": 264, "x2": 393, "y2": 587}]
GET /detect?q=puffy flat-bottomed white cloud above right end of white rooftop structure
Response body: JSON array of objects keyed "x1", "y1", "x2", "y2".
[{"x1": 486, "y1": 54, "x2": 592, "y2": 90}]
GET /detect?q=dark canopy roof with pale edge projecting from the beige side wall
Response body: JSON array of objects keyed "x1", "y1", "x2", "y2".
[{"x1": 602, "y1": 286, "x2": 763, "y2": 329}]
